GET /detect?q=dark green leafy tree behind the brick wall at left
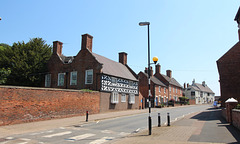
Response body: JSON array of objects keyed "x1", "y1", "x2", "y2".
[{"x1": 0, "y1": 38, "x2": 52, "y2": 86}]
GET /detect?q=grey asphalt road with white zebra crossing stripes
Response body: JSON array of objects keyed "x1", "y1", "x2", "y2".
[{"x1": 0, "y1": 105, "x2": 209, "y2": 144}]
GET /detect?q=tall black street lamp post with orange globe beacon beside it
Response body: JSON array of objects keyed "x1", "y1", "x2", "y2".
[{"x1": 139, "y1": 22, "x2": 158, "y2": 135}]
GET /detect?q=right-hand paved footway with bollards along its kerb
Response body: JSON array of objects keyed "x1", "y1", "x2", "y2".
[{"x1": 113, "y1": 108, "x2": 240, "y2": 144}]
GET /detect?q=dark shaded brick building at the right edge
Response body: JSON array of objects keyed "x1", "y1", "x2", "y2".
[{"x1": 217, "y1": 8, "x2": 240, "y2": 107}]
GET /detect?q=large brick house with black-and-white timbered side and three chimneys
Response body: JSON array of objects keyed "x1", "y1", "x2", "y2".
[{"x1": 45, "y1": 34, "x2": 139, "y2": 111}]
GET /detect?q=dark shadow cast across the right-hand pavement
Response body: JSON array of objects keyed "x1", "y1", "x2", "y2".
[{"x1": 191, "y1": 108, "x2": 240, "y2": 143}]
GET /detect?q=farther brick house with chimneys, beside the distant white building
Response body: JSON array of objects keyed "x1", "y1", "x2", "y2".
[{"x1": 154, "y1": 64, "x2": 183, "y2": 101}]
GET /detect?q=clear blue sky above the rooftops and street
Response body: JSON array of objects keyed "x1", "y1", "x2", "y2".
[{"x1": 0, "y1": 0, "x2": 239, "y2": 95}]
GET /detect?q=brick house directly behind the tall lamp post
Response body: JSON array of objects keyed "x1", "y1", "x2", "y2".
[{"x1": 138, "y1": 67, "x2": 168, "y2": 108}]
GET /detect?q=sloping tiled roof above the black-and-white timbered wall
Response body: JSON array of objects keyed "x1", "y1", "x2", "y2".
[{"x1": 92, "y1": 53, "x2": 138, "y2": 81}]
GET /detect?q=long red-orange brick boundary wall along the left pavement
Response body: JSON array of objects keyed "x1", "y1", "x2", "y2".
[{"x1": 0, "y1": 86, "x2": 101, "y2": 126}]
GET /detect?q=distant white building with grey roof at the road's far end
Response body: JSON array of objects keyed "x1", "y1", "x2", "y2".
[{"x1": 184, "y1": 80, "x2": 215, "y2": 104}]
